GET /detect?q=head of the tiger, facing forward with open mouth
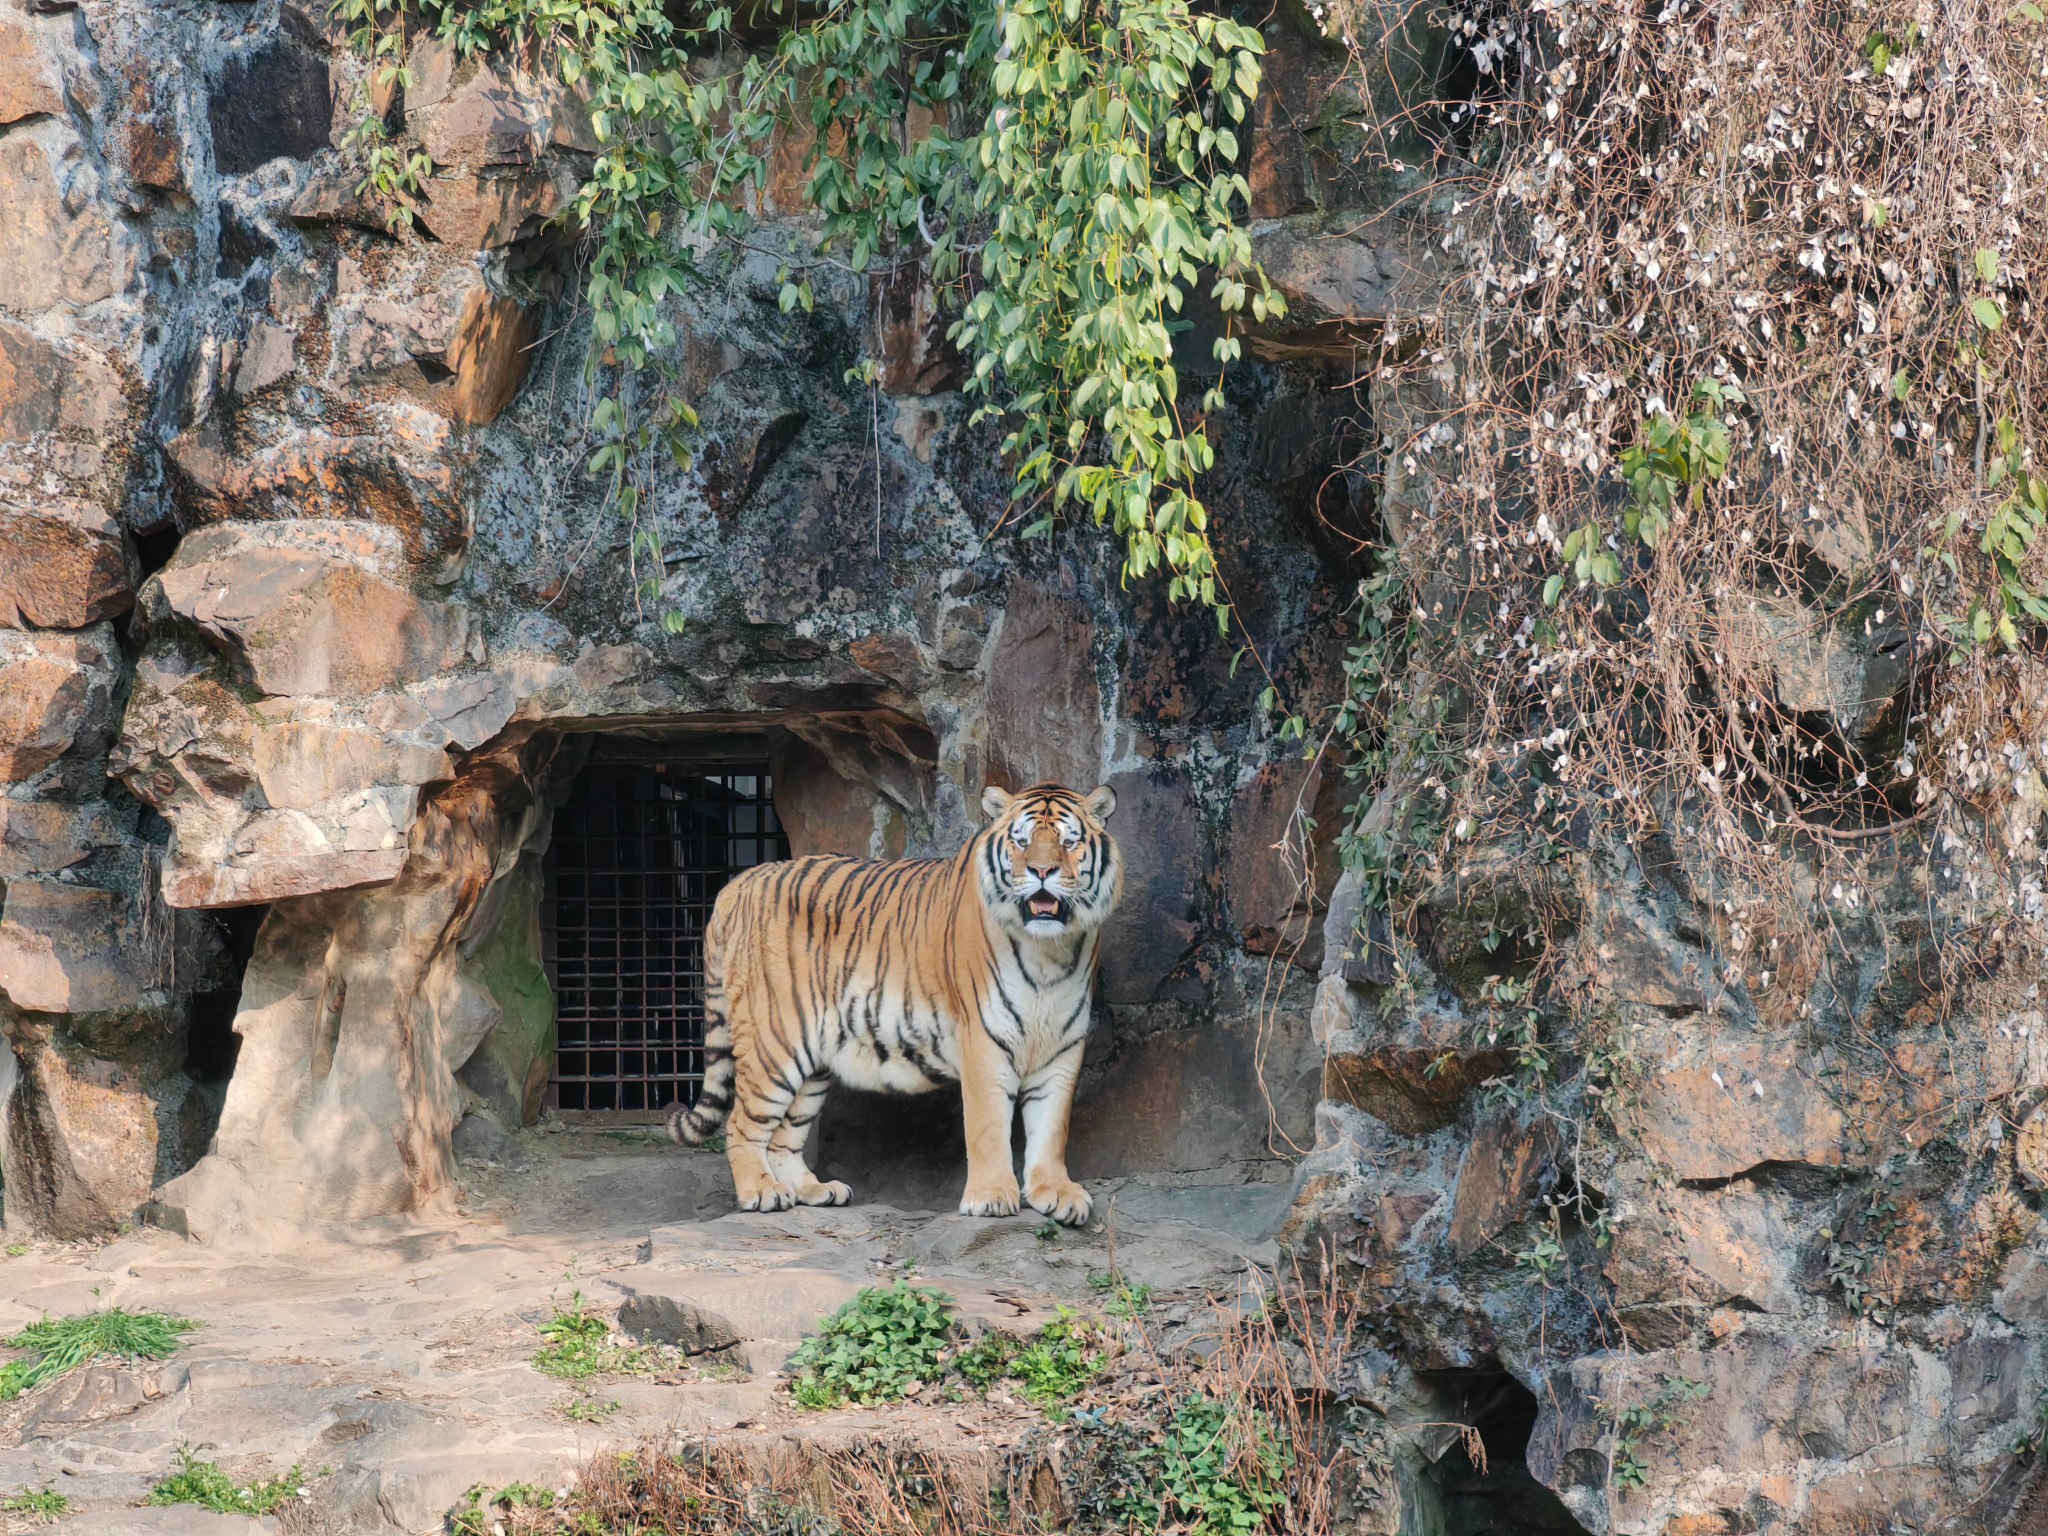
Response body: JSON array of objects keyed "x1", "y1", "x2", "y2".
[{"x1": 975, "y1": 784, "x2": 1124, "y2": 940}]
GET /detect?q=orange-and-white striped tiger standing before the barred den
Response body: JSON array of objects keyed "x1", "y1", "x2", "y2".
[{"x1": 668, "y1": 784, "x2": 1124, "y2": 1227}]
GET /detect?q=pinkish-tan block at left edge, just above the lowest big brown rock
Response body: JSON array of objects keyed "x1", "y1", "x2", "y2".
[{"x1": 0, "y1": 879, "x2": 152, "y2": 1014}]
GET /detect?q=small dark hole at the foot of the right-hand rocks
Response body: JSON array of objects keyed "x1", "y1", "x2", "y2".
[{"x1": 1417, "y1": 1366, "x2": 1585, "y2": 1536}]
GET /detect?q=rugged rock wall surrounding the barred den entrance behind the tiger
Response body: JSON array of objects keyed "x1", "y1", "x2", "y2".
[{"x1": 0, "y1": 0, "x2": 1364, "y2": 1233}]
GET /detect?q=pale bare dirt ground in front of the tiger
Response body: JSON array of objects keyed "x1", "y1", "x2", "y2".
[{"x1": 0, "y1": 1124, "x2": 1286, "y2": 1536}]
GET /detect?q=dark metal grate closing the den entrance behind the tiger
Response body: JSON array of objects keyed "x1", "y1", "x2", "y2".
[{"x1": 545, "y1": 762, "x2": 788, "y2": 1114}]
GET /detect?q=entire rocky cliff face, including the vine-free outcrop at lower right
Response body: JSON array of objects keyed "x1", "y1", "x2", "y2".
[{"x1": 0, "y1": 0, "x2": 2048, "y2": 1536}]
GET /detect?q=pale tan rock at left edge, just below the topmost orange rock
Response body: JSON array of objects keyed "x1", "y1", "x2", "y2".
[{"x1": 0, "y1": 123, "x2": 135, "y2": 311}]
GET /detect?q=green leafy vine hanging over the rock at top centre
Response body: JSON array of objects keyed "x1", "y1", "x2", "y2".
[{"x1": 336, "y1": 0, "x2": 1282, "y2": 629}]
